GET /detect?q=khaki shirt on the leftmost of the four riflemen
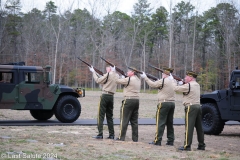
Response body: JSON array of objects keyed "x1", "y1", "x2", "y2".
[{"x1": 93, "y1": 72, "x2": 119, "y2": 93}]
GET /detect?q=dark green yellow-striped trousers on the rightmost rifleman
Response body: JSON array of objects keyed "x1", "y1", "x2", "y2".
[{"x1": 184, "y1": 104, "x2": 205, "y2": 149}]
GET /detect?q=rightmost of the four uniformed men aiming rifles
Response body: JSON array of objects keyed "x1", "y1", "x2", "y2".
[{"x1": 175, "y1": 71, "x2": 205, "y2": 151}]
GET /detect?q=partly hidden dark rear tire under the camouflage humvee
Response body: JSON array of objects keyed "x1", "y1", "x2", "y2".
[{"x1": 30, "y1": 110, "x2": 54, "y2": 121}]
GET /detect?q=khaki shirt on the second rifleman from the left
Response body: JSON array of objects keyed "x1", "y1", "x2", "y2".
[{"x1": 116, "y1": 75, "x2": 141, "y2": 98}]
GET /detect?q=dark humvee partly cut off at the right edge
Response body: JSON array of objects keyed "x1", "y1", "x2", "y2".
[{"x1": 200, "y1": 68, "x2": 240, "y2": 135}]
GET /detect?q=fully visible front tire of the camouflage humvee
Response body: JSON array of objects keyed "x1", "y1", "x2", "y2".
[{"x1": 54, "y1": 95, "x2": 81, "y2": 123}]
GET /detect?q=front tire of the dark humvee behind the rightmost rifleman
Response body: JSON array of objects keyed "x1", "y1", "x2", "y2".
[{"x1": 202, "y1": 103, "x2": 225, "y2": 135}]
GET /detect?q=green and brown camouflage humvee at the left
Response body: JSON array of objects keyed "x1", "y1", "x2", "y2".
[{"x1": 0, "y1": 62, "x2": 85, "y2": 123}]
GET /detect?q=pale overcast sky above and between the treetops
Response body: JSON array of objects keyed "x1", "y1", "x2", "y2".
[{"x1": 2, "y1": 0, "x2": 221, "y2": 15}]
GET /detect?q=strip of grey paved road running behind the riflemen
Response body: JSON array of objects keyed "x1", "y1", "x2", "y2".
[{"x1": 0, "y1": 118, "x2": 240, "y2": 126}]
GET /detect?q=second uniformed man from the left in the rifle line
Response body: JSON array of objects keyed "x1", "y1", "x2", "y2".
[{"x1": 116, "y1": 67, "x2": 141, "y2": 142}]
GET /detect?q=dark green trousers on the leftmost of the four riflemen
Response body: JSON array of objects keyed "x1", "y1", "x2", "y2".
[{"x1": 97, "y1": 94, "x2": 114, "y2": 136}]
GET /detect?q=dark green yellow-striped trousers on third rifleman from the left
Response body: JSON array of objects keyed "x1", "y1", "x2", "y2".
[{"x1": 154, "y1": 102, "x2": 175, "y2": 144}]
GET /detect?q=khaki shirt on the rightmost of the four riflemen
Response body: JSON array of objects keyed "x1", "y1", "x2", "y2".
[{"x1": 175, "y1": 81, "x2": 200, "y2": 106}]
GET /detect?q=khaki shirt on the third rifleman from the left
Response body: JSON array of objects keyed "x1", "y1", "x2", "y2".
[{"x1": 145, "y1": 77, "x2": 175, "y2": 102}]
